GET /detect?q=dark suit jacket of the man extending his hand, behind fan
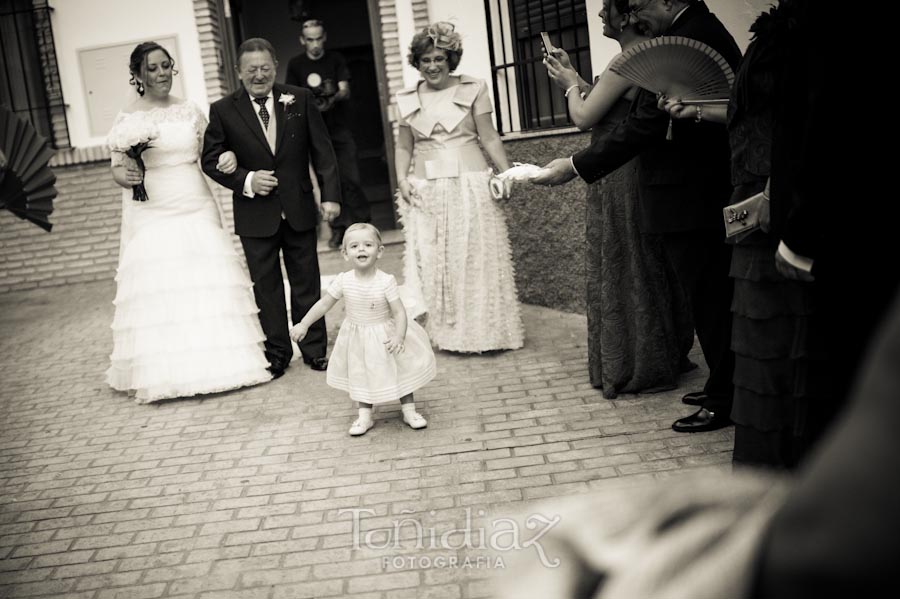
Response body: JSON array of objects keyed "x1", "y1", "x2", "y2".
[{"x1": 574, "y1": 2, "x2": 741, "y2": 233}]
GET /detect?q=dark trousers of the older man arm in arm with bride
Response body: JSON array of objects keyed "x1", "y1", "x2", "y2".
[{"x1": 241, "y1": 219, "x2": 328, "y2": 366}]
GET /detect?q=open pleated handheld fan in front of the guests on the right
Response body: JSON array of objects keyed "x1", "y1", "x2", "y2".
[{"x1": 609, "y1": 35, "x2": 734, "y2": 104}]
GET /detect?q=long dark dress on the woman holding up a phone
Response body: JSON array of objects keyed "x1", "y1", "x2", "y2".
[{"x1": 585, "y1": 99, "x2": 694, "y2": 399}]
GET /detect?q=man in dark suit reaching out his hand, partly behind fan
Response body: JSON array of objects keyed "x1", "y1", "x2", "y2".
[{"x1": 533, "y1": 0, "x2": 740, "y2": 432}]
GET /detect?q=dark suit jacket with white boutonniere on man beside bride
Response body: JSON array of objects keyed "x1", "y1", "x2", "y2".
[{"x1": 202, "y1": 84, "x2": 341, "y2": 237}]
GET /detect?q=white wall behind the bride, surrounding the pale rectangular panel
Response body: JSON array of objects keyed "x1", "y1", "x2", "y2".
[{"x1": 50, "y1": 0, "x2": 207, "y2": 147}]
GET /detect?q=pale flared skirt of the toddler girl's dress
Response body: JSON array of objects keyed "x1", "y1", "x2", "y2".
[{"x1": 325, "y1": 319, "x2": 436, "y2": 404}]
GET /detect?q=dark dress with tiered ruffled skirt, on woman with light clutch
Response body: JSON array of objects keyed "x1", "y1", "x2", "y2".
[{"x1": 728, "y1": 11, "x2": 832, "y2": 468}]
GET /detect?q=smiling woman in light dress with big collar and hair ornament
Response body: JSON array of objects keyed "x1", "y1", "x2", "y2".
[{"x1": 396, "y1": 23, "x2": 524, "y2": 352}]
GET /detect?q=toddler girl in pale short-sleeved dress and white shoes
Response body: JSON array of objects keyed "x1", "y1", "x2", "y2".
[{"x1": 291, "y1": 223, "x2": 435, "y2": 436}]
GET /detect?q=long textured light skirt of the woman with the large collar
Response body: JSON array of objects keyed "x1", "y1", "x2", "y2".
[{"x1": 398, "y1": 170, "x2": 525, "y2": 352}]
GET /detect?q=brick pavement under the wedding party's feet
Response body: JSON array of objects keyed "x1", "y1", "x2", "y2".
[{"x1": 0, "y1": 245, "x2": 733, "y2": 599}]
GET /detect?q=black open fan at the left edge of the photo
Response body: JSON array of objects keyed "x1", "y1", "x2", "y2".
[{"x1": 0, "y1": 106, "x2": 57, "y2": 231}]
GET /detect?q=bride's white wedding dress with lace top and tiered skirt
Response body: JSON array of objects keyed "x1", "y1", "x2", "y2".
[{"x1": 106, "y1": 102, "x2": 272, "y2": 403}]
